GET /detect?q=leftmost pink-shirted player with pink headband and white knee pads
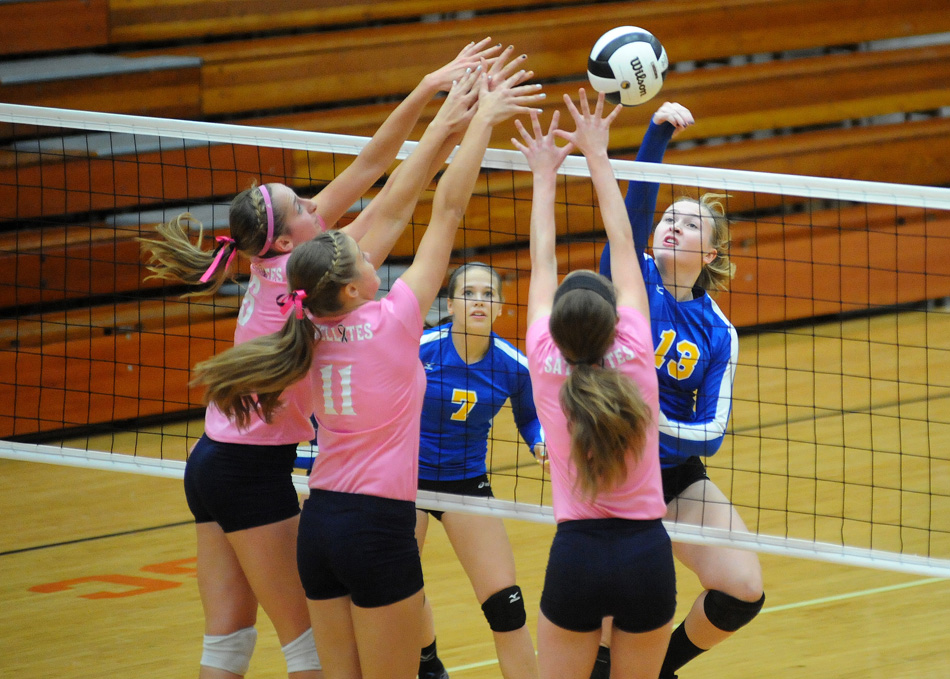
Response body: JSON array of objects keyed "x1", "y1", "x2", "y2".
[{"x1": 144, "y1": 39, "x2": 500, "y2": 679}]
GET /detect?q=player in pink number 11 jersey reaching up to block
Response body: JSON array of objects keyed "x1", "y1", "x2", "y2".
[{"x1": 189, "y1": 58, "x2": 543, "y2": 679}]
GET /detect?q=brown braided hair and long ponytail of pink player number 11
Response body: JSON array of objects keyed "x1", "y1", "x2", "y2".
[{"x1": 192, "y1": 231, "x2": 357, "y2": 427}]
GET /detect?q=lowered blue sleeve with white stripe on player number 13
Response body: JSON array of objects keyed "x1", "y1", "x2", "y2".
[{"x1": 659, "y1": 325, "x2": 739, "y2": 459}]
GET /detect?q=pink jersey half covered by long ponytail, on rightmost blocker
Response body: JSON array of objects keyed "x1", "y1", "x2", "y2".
[{"x1": 525, "y1": 307, "x2": 666, "y2": 522}]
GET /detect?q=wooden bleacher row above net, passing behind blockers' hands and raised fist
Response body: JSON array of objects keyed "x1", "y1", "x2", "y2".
[{"x1": 249, "y1": 44, "x2": 950, "y2": 151}]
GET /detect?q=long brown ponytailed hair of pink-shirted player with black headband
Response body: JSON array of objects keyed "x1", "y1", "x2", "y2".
[{"x1": 550, "y1": 271, "x2": 652, "y2": 498}]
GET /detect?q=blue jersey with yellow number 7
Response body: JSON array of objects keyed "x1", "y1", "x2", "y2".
[{"x1": 419, "y1": 324, "x2": 544, "y2": 481}]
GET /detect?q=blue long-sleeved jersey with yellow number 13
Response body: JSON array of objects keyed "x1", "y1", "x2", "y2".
[{"x1": 600, "y1": 121, "x2": 739, "y2": 468}]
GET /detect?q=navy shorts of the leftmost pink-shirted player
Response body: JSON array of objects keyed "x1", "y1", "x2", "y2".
[{"x1": 185, "y1": 436, "x2": 300, "y2": 533}]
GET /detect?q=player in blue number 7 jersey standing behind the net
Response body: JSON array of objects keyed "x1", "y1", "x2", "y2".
[{"x1": 416, "y1": 262, "x2": 545, "y2": 679}]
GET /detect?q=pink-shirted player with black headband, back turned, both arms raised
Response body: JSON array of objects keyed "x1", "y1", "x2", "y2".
[{"x1": 515, "y1": 89, "x2": 676, "y2": 679}]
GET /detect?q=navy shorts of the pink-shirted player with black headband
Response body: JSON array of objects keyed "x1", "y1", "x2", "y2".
[{"x1": 541, "y1": 519, "x2": 676, "y2": 634}]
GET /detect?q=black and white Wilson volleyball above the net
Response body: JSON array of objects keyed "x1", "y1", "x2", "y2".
[{"x1": 587, "y1": 26, "x2": 670, "y2": 106}]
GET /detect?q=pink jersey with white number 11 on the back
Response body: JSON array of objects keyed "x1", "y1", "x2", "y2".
[{"x1": 310, "y1": 279, "x2": 426, "y2": 502}]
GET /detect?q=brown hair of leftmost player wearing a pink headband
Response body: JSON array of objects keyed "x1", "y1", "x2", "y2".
[{"x1": 137, "y1": 186, "x2": 286, "y2": 297}]
